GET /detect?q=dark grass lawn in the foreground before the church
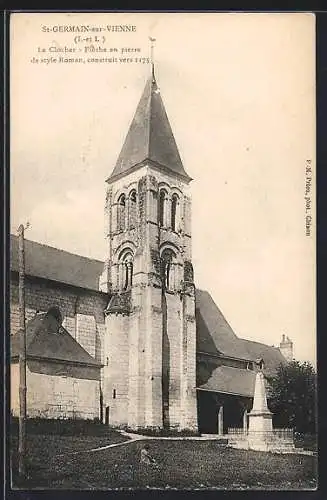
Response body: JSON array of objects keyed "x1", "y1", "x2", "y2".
[{"x1": 11, "y1": 431, "x2": 317, "y2": 490}]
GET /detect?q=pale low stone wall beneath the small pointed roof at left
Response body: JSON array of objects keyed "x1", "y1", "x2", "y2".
[{"x1": 10, "y1": 360, "x2": 100, "y2": 419}]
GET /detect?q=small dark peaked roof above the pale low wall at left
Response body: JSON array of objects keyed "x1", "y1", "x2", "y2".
[{"x1": 11, "y1": 312, "x2": 101, "y2": 367}]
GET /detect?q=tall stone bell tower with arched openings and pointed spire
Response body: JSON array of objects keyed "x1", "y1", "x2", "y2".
[{"x1": 100, "y1": 66, "x2": 197, "y2": 430}]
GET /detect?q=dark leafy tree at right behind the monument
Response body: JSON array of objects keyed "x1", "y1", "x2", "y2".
[{"x1": 268, "y1": 361, "x2": 317, "y2": 433}]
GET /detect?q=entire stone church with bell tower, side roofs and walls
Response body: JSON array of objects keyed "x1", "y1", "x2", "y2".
[{"x1": 11, "y1": 67, "x2": 293, "y2": 433}]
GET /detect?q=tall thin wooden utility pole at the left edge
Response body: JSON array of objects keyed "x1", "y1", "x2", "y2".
[{"x1": 18, "y1": 224, "x2": 29, "y2": 478}]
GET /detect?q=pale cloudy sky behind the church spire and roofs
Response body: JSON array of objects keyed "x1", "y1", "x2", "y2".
[{"x1": 10, "y1": 13, "x2": 316, "y2": 364}]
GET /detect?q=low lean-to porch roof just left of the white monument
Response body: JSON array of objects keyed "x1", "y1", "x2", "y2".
[{"x1": 198, "y1": 366, "x2": 256, "y2": 397}]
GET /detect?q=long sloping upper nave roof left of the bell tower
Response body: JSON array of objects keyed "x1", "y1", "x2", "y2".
[{"x1": 10, "y1": 235, "x2": 103, "y2": 291}]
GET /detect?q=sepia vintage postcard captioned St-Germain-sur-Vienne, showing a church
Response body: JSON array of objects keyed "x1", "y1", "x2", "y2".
[{"x1": 8, "y1": 12, "x2": 318, "y2": 490}]
